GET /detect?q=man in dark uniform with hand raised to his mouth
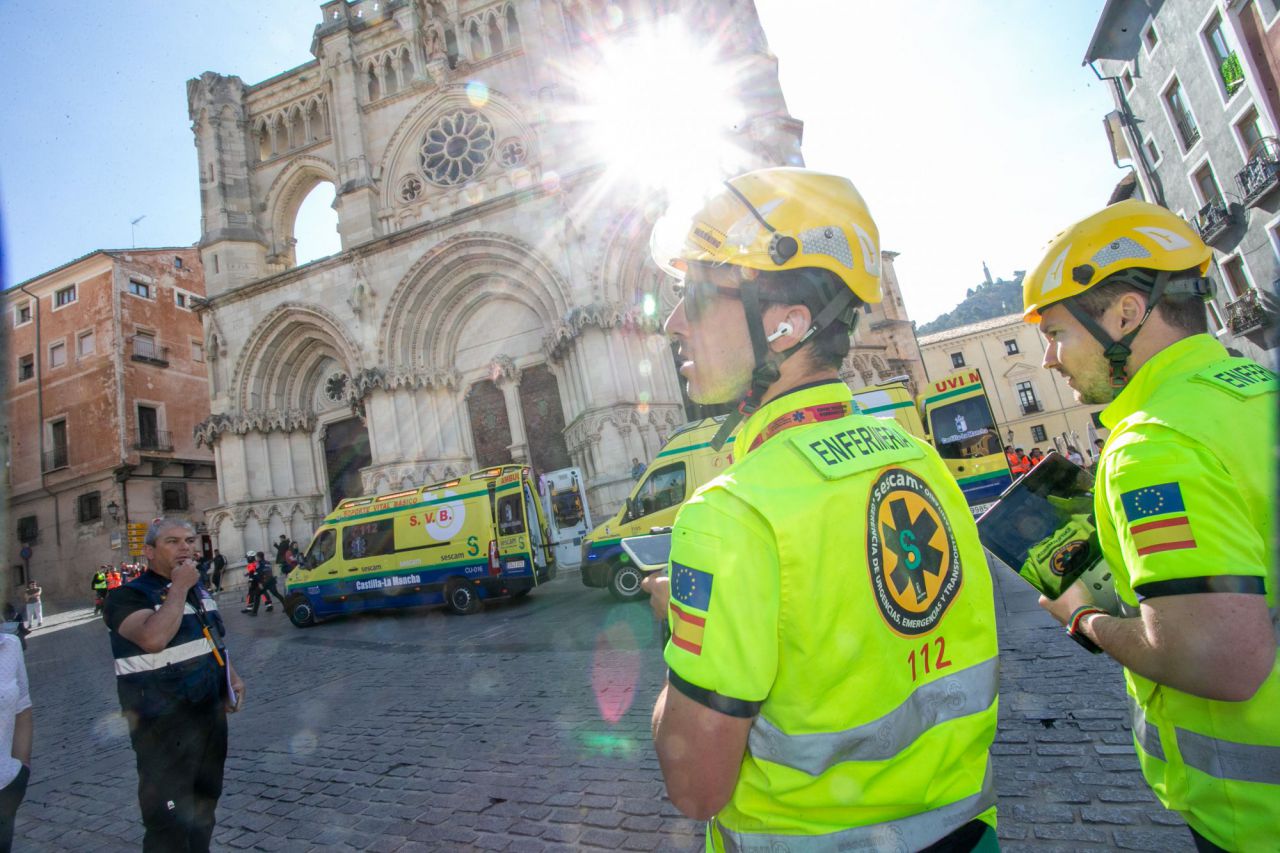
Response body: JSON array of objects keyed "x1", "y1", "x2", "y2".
[{"x1": 104, "y1": 519, "x2": 244, "y2": 853}]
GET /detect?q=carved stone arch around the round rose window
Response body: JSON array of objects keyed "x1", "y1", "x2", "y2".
[{"x1": 378, "y1": 83, "x2": 538, "y2": 209}]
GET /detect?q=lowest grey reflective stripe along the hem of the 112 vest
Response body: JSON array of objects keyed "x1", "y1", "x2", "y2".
[{"x1": 713, "y1": 763, "x2": 996, "y2": 853}]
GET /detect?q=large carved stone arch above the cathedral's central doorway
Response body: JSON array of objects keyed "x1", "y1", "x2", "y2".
[{"x1": 378, "y1": 232, "x2": 570, "y2": 373}]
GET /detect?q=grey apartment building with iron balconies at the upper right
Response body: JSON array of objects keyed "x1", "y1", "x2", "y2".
[{"x1": 1084, "y1": 0, "x2": 1280, "y2": 365}]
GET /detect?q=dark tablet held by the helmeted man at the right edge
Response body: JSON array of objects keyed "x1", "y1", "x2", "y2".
[{"x1": 978, "y1": 451, "x2": 1110, "y2": 598}]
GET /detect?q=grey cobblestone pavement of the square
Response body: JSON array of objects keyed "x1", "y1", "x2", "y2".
[{"x1": 17, "y1": 560, "x2": 1190, "y2": 853}]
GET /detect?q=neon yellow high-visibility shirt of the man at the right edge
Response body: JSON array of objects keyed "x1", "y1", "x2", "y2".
[{"x1": 1094, "y1": 334, "x2": 1280, "y2": 850}]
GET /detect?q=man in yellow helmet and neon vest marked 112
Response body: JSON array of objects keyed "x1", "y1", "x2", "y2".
[{"x1": 645, "y1": 168, "x2": 997, "y2": 850}]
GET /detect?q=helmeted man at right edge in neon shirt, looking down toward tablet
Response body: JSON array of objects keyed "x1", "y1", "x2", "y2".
[{"x1": 1023, "y1": 200, "x2": 1280, "y2": 850}]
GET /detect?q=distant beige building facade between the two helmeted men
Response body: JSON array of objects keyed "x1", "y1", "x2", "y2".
[{"x1": 920, "y1": 314, "x2": 1106, "y2": 459}]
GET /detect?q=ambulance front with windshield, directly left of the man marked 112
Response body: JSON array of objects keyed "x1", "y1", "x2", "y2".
[{"x1": 581, "y1": 415, "x2": 733, "y2": 601}]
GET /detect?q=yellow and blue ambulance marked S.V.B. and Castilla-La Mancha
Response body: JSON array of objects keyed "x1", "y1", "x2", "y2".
[{"x1": 284, "y1": 465, "x2": 556, "y2": 628}]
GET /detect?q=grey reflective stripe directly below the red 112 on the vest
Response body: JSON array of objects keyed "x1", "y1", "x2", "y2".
[{"x1": 748, "y1": 658, "x2": 1000, "y2": 776}]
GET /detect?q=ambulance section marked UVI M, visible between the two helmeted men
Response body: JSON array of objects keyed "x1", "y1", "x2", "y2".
[{"x1": 854, "y1": 368, "x2": 1014, "y2": 515}]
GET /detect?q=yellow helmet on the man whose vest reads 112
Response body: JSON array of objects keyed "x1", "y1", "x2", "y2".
[{"x1": 652, "y1": 167, "x2": 881, "y2": 302}]
